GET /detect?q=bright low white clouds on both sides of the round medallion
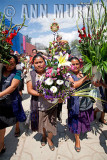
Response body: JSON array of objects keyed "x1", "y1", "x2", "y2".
[{"x1": 31, "y1": 31, "x2": 78, "y2": 47}]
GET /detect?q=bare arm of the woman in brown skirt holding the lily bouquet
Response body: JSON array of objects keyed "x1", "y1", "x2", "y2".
[{"x1": 27, "y1": 81, "x2": 42, "y2": 96}]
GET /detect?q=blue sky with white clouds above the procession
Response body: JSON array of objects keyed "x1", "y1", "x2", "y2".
[{"x1": 0, "y1": 0, "x2": 107, "y2": 47}]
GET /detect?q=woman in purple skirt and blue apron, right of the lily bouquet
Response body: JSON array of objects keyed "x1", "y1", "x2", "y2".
[{"x1": 68, "y1": 57, "x2": 94, "y2": 152}]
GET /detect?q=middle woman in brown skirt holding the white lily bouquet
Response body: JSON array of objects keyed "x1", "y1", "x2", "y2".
[{"x1": 27, "y1": 53, "x2": 57, "y2": 151}]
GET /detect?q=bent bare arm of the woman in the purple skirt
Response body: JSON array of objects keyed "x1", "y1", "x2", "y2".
[{"x1": 69, "y1": 76, "x2": 89, "y2": 88}]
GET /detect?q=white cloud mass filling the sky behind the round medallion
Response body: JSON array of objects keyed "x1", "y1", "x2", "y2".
[{"x1": 24, "y1": 0, "x2": 106, "y2": 47}]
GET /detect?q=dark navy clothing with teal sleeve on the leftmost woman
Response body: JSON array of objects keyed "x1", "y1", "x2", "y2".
[{"x1": 0, "y1": 69, "x2": 26, "y2": 129}]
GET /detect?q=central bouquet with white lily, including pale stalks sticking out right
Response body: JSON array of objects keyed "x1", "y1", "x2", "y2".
[{"x1": 36, "y1": 39, "x2": 105, "y2": 107}]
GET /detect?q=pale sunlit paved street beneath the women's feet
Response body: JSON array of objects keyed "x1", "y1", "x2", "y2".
[{"x1": 0, "y1": 82, "x2": 107, "y2": 160}]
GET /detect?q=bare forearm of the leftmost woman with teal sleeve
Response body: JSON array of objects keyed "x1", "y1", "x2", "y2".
[{"x1": 0, "y1": 79, "x2": 20, "y2": 97}]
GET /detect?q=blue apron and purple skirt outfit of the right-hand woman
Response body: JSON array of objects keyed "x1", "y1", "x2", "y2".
[{"x1": 67, "y1": 75, "x2": 94, "y2": 134}]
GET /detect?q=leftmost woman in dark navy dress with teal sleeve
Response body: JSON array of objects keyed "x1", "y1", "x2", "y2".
[{"x1": 0, "y1": 55, "x2": 26, "y2": 154}]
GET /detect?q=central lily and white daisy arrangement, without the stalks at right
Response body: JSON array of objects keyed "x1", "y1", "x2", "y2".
[{"x1": 36, "y1": 43, "x2": 73, "y2": 103}]
